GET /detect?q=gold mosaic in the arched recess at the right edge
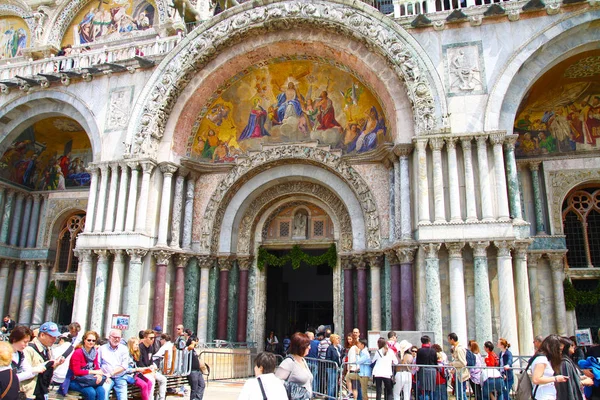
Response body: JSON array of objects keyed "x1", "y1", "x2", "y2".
[{"x1": 514, "y1": 50, "x2": 600, "y2": 157}]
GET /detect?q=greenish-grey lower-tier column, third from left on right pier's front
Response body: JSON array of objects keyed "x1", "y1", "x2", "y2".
[{"x1": 469, "y1": 241, "x2": 493, "y2": 343}]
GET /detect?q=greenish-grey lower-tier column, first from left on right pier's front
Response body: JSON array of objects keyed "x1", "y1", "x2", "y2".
[{"x1": 421, "y1": 243, "x2": 444, "y2": 343}]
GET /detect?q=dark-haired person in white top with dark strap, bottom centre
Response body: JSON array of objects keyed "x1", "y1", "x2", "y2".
[{"x1": 238, "y1": 352, "x2": 287, "y2": 400}]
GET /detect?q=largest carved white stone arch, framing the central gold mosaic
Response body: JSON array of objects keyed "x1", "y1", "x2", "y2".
[{"x1": 126, "y1": 0, "x2": 447, "y2": 157}]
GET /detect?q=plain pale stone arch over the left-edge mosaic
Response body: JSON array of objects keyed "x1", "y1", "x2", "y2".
[{"x1": 0, "y1": 90, "x2": 102, "y2": 161}]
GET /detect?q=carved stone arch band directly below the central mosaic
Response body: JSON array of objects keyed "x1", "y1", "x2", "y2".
[{"x1": 200, "y1": 145, "x2": 380, "y2": 253}]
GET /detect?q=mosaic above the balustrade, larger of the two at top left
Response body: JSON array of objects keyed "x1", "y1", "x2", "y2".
[{"x1": 62, "y1": 0, "x2": 156, "y2": 47}]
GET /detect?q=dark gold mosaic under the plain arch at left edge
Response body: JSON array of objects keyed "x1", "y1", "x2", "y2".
[{"x1": 0, "y1": 117, "x2": 92, "y2": 190}]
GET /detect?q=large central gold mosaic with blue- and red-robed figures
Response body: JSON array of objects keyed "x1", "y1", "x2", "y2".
[{"x1": 187, "y1": 57, "x2": 390, "y2": 162}]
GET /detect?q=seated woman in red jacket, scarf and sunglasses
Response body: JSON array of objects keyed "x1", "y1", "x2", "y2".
[{"x1": 69, "y1": 331, "x2": 106, "y2": 400}]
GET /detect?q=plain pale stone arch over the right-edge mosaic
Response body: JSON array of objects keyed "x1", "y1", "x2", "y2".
[{"x1": 484, "y1": 10, "x2": 600, "y2": 132}]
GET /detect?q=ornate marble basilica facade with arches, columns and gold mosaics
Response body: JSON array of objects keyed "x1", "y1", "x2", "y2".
[{"x1": 0, "y1": 0, "x2": 600, "y2": 355}]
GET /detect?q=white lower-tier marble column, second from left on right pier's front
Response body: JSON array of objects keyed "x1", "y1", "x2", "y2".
[{"x1": 446, "y1": 242, "x2": 469, "y2": 343}]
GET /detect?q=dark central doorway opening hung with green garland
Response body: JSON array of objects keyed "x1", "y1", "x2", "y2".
[{"x1": 265, "y1": 249, "x2": 333, "y2": 343}]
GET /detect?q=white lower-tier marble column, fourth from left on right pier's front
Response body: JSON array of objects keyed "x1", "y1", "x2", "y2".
[{"x1": 494, "y1": 241, "x2": 520, "y2": 354}]
